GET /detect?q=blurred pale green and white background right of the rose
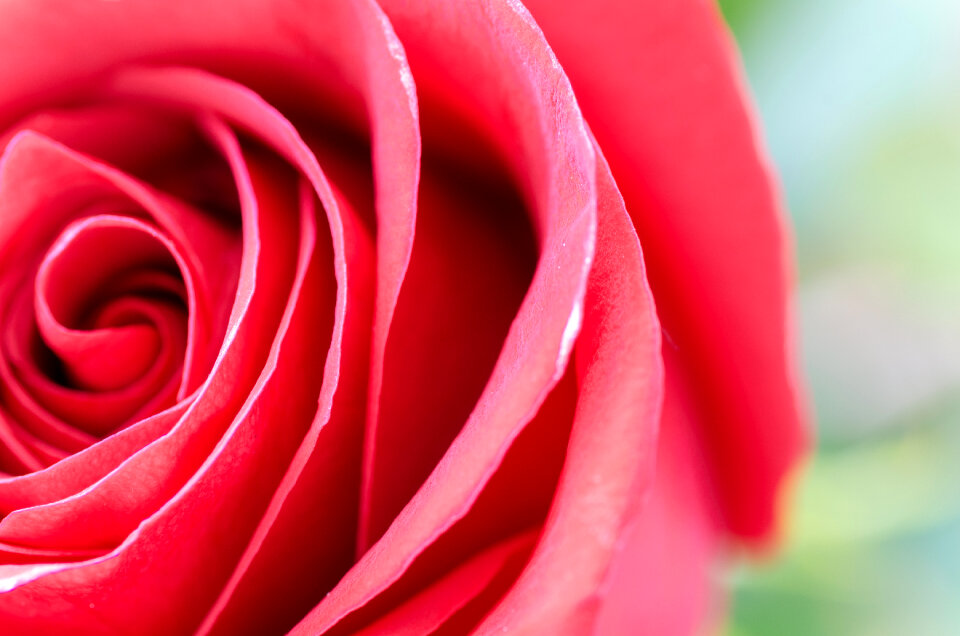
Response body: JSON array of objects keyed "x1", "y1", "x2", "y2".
[{"x1": 720, "y1": 0, "x2": 960, "y2": 636}]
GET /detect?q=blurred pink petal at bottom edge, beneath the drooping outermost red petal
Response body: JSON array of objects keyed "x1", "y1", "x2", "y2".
[{"x1": 590, "y1": 344, "x2": 722, "y2": 636}]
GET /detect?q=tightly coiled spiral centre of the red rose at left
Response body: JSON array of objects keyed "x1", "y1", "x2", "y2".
[{"x1": 5, "y1": 216, "x2": 193, "y2": 435}]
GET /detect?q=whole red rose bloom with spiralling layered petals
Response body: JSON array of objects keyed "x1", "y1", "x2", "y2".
[{"x1": 0, "y1": 0, "x2": 804, "y2": 635}]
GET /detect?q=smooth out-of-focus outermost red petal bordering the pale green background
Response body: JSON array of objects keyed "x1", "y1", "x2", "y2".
[{"x1": 527, "y1": 0, "x2": 804, "y2": 539}]
